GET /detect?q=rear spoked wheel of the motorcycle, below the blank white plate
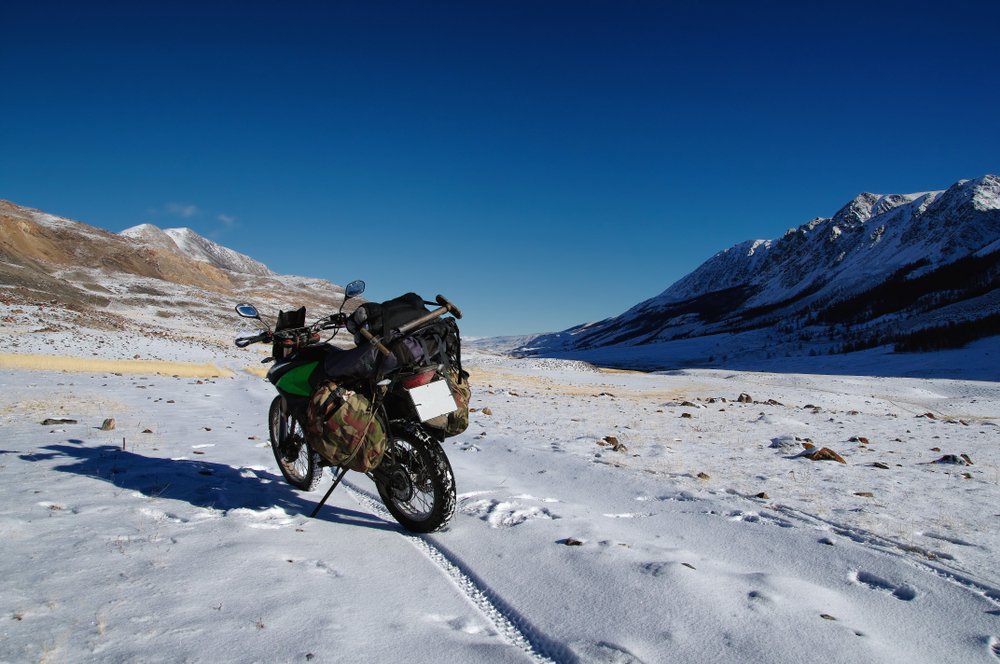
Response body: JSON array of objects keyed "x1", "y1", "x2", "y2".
[{"x1": 373, "y1": 427, "x2": 455, "y2": 533}]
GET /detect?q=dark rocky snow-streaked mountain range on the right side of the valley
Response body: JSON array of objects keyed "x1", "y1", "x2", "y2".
[{"x1": 520, "y1": 175, "x2": 1000, "y2": 367}]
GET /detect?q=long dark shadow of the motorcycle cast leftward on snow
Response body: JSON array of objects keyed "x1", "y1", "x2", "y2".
[{"x1": 21, "y1": 439, "x2": 399, "y2": 531}]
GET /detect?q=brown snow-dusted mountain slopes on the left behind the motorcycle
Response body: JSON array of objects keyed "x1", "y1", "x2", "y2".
[{"x1": 0, "y1": 201, "x2": 356, "y2": 344}]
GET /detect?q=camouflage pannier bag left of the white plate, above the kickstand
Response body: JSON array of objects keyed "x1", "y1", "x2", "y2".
[{"x1": 306, "y1": 381, "x2": 386, "y2": 473}]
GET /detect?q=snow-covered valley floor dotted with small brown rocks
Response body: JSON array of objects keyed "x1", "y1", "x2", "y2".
[{"x1": 0, "y1": 330, "x2": 1000, "y2": 662}]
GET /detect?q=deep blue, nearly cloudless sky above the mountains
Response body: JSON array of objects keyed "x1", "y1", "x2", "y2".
[{"x1": 0, "y1": 0, "x2": 1000, "y2": 335}]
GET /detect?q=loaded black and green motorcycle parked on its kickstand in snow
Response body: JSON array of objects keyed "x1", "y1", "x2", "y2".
[{"x1": 236, "y1": 280, "x2": 467, "y2": 533}]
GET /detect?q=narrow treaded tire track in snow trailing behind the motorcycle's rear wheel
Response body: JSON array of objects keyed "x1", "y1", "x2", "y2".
[{"x1": 343, "y1": 480, "x2": 578, "y2": 664}]
